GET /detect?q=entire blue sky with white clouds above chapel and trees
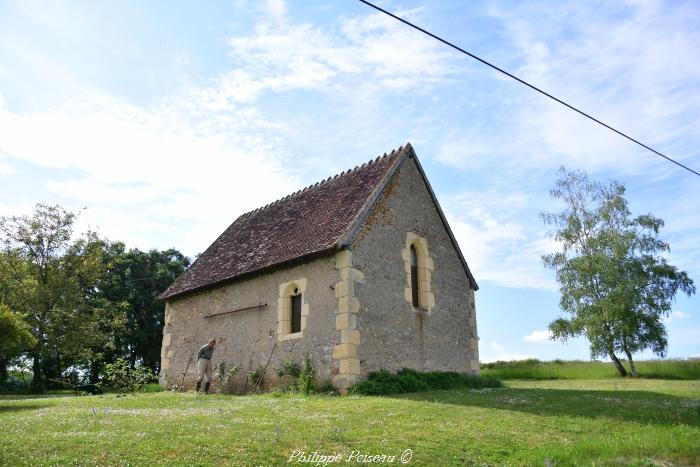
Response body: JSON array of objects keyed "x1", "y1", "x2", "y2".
[{"x1": 0, "y1": 0, "x2": 700, "y2": 361}]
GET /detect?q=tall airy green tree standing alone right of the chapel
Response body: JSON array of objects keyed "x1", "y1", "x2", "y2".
[{"x1": 542, "y1": 168, "x2": 695, "y2": 376}]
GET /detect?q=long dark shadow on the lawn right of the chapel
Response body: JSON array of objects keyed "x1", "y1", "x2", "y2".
[{"x1": 394, "y1": 388, "x2": 700, "y2": 427}]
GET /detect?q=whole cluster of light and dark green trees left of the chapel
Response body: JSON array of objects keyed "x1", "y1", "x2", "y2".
[{"x1": 0, "y1": 204, "x2": 189, "y2": 388}]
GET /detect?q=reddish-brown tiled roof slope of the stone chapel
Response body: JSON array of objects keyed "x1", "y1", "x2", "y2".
[{"x1": 159, "y1": 144, "x2": 413, "y2": 299}]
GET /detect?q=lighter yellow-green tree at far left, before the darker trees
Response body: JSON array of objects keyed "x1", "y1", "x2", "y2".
[{"x1": 0, "y1": 204, "x2": 117, "y2": 388}]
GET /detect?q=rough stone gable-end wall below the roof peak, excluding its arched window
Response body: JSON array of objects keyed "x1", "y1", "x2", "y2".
[{"x1": 353, "y1": 159, "x2": 479, "y2": 376}]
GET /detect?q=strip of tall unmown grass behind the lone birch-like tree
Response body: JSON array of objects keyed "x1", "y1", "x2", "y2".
[{"x1": 481, "y1": 358, "x2": 700, "y2": 380}]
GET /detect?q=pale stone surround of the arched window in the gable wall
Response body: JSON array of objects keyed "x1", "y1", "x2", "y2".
[{"x1": 401, "y1": 232, "x2": 435, "y2": 312}]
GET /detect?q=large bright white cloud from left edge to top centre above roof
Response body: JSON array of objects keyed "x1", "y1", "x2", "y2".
[{"x1": 0, "y1": 1, "x2": 464, "y2": 254}]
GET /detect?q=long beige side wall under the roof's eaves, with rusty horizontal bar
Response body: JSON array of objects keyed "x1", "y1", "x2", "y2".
[{"x1": 160, "y1": 254, "x2": 340, "y2": 388}]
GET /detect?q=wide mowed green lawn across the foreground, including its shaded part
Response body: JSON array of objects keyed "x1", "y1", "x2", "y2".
[{"x1": 0, "y1": 379, "x2": 700, "y2": 465}]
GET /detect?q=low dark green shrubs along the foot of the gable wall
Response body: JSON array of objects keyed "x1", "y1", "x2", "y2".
[{"x1": 350, "y1": 368, "x2": 502, "y2": 396}]
